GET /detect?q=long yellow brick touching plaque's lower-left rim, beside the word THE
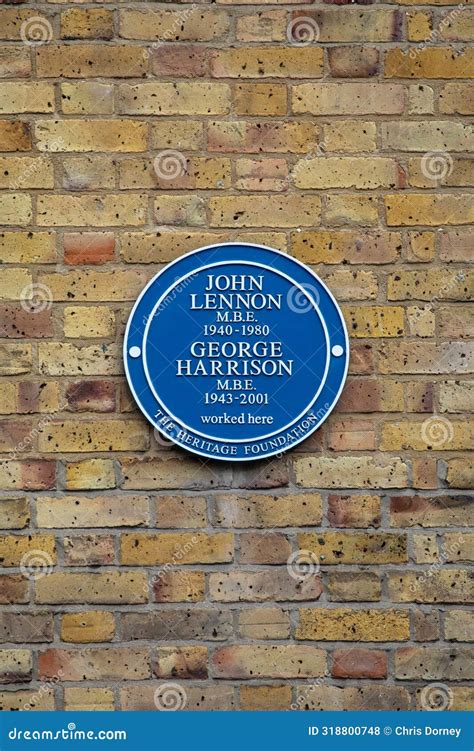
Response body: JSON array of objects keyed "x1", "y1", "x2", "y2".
[{"x1": 38, "y1": 420, "x2": 149, "y2": 453}]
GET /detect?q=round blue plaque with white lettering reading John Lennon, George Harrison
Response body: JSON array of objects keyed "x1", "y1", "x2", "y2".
[{"x1": 124, "y1": 242, "x2": 349, "y2": 461}]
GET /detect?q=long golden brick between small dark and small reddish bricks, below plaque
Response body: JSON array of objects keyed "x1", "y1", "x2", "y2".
[{"x1": 121, "y1": 532, "x2": 234, "y2": 566}]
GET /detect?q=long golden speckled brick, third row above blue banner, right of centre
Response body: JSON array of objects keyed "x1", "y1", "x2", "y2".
[{"x1": 296, "y1": 608, "x2": 410, "y2": 642}]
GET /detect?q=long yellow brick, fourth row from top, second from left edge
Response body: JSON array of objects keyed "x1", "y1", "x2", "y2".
[{"x1": 35, "y1": 120, "x2": 148, "y2": 152}]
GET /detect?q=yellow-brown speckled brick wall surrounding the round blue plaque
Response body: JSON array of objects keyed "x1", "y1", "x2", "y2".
[{"x1": 0, "y1": 0, "x2": 474, "y2": 709}]
